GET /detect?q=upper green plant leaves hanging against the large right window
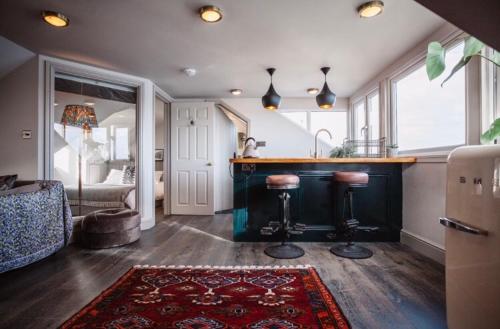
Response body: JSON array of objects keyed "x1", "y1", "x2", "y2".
[{"x1": 425, "y1": 37, "x2": 500, "y2": 87}]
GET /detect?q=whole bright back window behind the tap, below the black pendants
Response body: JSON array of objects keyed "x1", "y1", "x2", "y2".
[{"x1": 280, "y1": 110, "x2": 347, "y2": 146}]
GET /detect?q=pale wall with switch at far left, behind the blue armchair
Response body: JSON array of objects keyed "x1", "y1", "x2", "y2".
[{"x1": 0, "y1": 57, "x2": 41, "y2": 180}]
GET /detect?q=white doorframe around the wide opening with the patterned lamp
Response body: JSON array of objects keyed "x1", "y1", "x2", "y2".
[{"x1": 38, "y1": 55, "x2": 172, "y2": 230}]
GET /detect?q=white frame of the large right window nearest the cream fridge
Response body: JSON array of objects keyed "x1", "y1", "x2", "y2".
[{"x1": 387, "y1": 33, "x2": 472, "y2": 156}]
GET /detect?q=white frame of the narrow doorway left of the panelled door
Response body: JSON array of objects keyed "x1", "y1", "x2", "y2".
[{"x1": 153, "y1": 86, "x2": 173, "y2": 216}]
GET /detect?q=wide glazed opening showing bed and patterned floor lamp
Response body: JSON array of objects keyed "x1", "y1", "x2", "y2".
[{"x1": 53, "y1": 73, "x2": 138, "y2": 216}]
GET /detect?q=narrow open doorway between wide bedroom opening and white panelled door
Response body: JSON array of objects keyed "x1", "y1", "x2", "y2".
[{"x1": 154, "y1": 95, "x2": 171, "y2": 216}]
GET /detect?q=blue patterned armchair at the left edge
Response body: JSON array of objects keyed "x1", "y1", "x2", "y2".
[{"x1": 0, "y1": 181, "x2": 73, "y2": 273}]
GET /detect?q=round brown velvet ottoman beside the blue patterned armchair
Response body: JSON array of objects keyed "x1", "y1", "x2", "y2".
[{"x1": 80, "y1": 208, "x2": 141, "y2": 249}]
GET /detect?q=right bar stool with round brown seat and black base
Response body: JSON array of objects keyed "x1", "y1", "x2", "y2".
[{"x1": 330, "y1": 171, "x2": 373, "y2": 259}]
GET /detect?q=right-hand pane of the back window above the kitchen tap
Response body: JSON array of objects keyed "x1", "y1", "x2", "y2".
[{"x1": 311, "y1": 112, "x2": 347, "y2": 146}]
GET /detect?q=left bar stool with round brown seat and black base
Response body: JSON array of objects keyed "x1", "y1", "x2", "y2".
[{"x1": 260, "y1": 175, "x2": 306, "y2": 259}]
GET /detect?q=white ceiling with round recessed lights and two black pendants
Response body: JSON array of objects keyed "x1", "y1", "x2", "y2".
[{"x1": 0, "y1": 0, "x2": 444, "y2": 98}]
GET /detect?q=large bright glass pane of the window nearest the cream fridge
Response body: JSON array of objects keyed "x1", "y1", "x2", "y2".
[{"x1": 393, "y1": 43, "x2": 465, "y2": 150}]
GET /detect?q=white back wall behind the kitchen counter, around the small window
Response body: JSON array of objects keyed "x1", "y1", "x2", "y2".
[{"x1": 222, "y1": 98, "x2": 347, "y2": 158}]
